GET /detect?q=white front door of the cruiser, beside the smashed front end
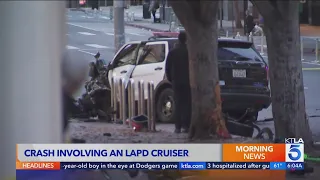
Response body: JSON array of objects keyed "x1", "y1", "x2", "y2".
[{"x1": 108, "y1": 42, "x2": 140, "y2": 82}]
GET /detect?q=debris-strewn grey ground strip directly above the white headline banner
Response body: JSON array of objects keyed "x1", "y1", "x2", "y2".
[{"x1": 69, "y1": 121, "x2": 257, "y2": 143}]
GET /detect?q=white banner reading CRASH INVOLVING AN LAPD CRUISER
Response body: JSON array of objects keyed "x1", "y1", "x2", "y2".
[{"x1": 17, "y1": 144, "x2": 222, "y2": 162}]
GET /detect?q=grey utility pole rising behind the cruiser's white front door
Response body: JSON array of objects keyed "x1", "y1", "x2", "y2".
[{"x1": 113, "y1": 0, "x2": 125, "y2": 52}]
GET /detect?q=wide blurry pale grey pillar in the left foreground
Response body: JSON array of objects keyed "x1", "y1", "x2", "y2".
[{"x1": 0, "y1": 1, "x2": 66, "y2": 180}]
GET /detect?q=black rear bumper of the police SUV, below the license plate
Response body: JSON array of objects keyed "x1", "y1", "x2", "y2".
[{"x1": 221, "y1": 92, "x2": 271, "y2": 111}]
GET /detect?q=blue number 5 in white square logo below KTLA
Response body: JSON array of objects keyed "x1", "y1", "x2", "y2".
[{"x1": 286, "y1": 141, "x2": 304, "y2": 162}]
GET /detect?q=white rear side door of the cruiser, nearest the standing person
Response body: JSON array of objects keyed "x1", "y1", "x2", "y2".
[{"x1": 131, "y1": 41, "x2": 169, "y2": 99}]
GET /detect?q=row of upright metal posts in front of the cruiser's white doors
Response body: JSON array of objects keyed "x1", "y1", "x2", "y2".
[{"x1": 110, "y1": 77, "x2": 156, "y2": 131}]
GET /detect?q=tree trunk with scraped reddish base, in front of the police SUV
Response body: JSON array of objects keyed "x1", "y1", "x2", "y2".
[{"x1": 171, "y1": 1, "x2": 231, "y2": 139}]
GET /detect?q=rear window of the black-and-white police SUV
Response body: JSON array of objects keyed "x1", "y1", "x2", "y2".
[{"x1": 218, "y1": 42, "x2": 263, "y2": 62}]
